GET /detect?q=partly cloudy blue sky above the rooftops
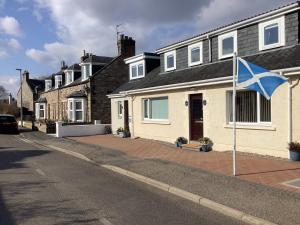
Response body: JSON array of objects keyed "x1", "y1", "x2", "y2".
[{"x1": 0, "y1": 0, "x2": 295, "y2": 95}]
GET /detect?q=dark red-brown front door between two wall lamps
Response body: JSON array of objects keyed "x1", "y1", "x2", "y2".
[{"x1": 190, "y1": 94, "x2": 203, "y2": 140}]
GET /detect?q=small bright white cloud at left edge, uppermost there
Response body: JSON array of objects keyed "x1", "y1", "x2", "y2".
[{"x1": 0, "y1": 16, "x2": 22, "y2": 37}]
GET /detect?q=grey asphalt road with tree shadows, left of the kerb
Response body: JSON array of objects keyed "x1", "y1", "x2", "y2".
[{"x1": 0, "y1": 134, "x2": 243, "y2": 225}]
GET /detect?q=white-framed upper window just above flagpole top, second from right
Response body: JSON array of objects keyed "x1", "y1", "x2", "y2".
[{"x1": 218, "y1": 31, "x2": 237, "y2": 59}]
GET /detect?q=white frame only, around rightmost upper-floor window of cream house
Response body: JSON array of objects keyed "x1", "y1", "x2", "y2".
[{"x1": 258, "y1": 16, "x2": 285, "y2": 51}]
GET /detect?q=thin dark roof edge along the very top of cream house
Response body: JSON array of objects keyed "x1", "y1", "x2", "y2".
[{"x1": 157, "y1": 1, "x2": 300, "y2": 51}]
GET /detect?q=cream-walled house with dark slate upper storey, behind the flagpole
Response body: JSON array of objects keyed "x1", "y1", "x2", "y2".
[{"x1": 109, "y1": 2, "x2": 300, "y2": 158}]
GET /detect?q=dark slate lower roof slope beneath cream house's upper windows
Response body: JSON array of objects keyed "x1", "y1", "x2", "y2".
[{"x1": 112, "y1": 45, "x2": 300, "y2": 94}]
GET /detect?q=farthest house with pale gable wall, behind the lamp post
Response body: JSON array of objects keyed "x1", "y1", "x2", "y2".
[{"x1": 17, "y1": 71, "x2": 45, "y2": 116}]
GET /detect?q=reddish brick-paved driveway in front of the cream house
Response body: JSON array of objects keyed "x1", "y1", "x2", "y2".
[{"x1": 69, "y1": 135, "x2": 300, "y2": 193}]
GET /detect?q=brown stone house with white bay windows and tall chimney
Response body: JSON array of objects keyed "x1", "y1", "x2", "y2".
[{"x1": 35, "y1": 35, "x2": 135, "y2": 123}]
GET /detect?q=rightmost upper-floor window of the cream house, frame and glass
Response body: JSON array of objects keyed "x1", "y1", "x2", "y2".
[{"x1": 258, "y1": 16, "x2": 285, "y2": 50}]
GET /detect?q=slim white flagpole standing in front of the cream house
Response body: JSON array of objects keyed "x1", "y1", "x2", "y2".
[{"x1": 232, "y1": 52, "x2": 237, "y2": 176}]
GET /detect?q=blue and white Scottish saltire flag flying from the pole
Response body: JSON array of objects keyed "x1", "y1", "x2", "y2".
[{"x1": 236, "y1": 58, "x2": 287, "y2": 100}]
